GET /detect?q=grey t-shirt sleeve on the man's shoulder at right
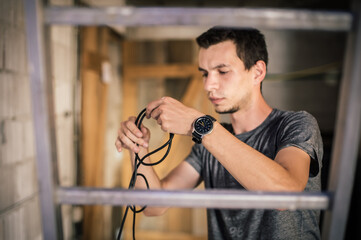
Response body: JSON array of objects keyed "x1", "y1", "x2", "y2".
[{"x1": 278, "y1": 111, "x2": 323, "y2": 177}]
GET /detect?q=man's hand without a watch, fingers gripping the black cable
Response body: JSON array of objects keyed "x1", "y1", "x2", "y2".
[{"x1": 115, "y1": 117, "x2": 150, "y2": 153}]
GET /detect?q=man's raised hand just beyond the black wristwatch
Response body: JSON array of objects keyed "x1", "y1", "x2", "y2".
[{"x1": 146, "y1": 97, "x2": 204, "y2": 136}]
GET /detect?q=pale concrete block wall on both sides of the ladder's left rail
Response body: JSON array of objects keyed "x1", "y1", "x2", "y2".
[{"x1": 0, "y1": 0, "x2": 77, "y2": 240}]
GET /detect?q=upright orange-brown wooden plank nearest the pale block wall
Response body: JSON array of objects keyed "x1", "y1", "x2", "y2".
[{"x1": 81, "y1": 27, "x2": 108, "y2": 240}]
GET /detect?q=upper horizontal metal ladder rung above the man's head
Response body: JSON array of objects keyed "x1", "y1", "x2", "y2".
[{"x1": 45, "y1": 7, "x2": 352, "y2": 31}]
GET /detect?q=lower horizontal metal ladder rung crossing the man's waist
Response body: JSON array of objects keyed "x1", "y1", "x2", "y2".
[{"x1": 57, "y1": 187, "x2": 330, "y2": 210}]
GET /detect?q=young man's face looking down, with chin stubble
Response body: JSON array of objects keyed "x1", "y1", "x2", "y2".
[{"x1": 199, "y1": 41, "x2": 255, "y2": 113}]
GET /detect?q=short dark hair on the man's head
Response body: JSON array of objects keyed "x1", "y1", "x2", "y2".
[{"x1": 196, "y1": 26, "x2": 268, "y2": 70}]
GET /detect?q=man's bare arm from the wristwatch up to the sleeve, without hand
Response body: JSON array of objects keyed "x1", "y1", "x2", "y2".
[{"x1": 202, "y1": 123, "x2": 311, "y2": 191}]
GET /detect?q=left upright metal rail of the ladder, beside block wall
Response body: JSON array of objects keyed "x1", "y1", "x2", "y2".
[{"x1": 24, "y1": 0, "x2": 63, "y2": 239}]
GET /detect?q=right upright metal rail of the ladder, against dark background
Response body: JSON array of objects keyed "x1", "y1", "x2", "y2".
[{"x1": 323, "y1": 1, "x2": 361, "y2": 240}]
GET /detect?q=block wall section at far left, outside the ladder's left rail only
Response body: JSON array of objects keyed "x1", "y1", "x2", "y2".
[{"x1": 0, "y1": 0, "x2": 42, "y2": 240}]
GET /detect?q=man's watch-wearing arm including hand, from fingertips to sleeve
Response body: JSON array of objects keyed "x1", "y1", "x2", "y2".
[{"x1": 146, "y1": 97, "x2": 311, "y2": 191}]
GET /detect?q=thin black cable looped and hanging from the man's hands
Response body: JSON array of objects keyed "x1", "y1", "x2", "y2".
[{"x1": 117, "y1": 109, "x2": 174, "y2": 240}]
